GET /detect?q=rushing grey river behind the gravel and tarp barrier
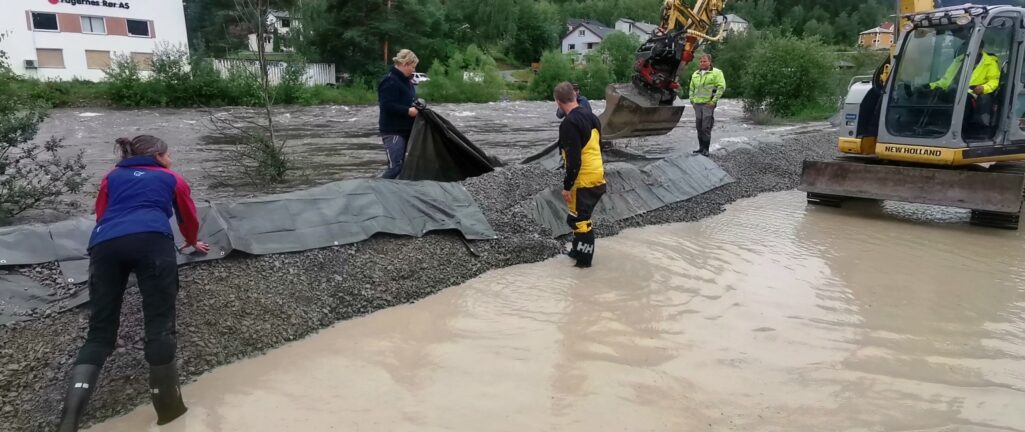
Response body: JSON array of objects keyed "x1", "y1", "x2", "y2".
[{"x1": 39, "y1": 101, "x2": 827, "y2": 203}]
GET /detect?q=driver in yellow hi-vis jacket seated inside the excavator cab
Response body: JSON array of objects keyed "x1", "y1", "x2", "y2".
[{"x1": 928, "y1": 42, "x2": 1000, "y2": 127}]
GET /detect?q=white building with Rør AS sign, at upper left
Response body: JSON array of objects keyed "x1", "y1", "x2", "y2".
[{"x1": 0, "y1": 0, "x2": 189, "y2": 81}]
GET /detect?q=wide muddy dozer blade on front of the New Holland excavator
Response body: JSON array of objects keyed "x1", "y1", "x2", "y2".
[{"x1": 797, "y1": 159, "x2": 1025, "y2": 222}]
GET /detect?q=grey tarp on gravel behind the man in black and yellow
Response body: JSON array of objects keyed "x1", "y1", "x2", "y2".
[{"x1": 532, "y1": 154, "x2": 733, "y2": 237}]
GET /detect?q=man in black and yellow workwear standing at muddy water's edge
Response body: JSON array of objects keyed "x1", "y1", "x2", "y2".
[{"x1": 554, "y1": 82, "x2": 606, "y2": 268}]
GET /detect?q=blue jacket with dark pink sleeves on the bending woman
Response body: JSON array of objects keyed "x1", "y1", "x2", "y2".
[{"x1": 89, "y1": 156, "x2": 199, "y2": 249}]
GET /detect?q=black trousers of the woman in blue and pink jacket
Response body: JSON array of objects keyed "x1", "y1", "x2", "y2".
[{"x1": 75, "y1": 233, "x2": 178, "y2": 367}]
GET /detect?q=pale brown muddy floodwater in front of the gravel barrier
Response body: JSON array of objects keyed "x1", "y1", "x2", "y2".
[{"x1": 90, "y1": 192, "x2": 1025, "y2": 432}]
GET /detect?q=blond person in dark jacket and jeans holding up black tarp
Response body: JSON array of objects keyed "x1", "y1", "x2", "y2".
[{"x1": 377, "y1": 49, "x2": 420, "y2": 179}]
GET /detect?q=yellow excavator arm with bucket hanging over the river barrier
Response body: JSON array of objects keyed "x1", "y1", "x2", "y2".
[{"x1": 599, "y1": 0, "x2": 726, "y2": 141}]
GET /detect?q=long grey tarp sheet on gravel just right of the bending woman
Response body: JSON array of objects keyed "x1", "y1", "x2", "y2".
[{"x1": 214, "y1": 181, "x2": 497, "y2": 254}]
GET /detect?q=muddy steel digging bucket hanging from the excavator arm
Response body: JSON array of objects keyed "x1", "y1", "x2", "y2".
[{"x1": 599, "y1": 84, "x2": 684, "y2": 141}]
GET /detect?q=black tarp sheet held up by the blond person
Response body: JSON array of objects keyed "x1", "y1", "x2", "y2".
[{"x1": 399, "y1": 109, "x2": 501, "y2": 182}]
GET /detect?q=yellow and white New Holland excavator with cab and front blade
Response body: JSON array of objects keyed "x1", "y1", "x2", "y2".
[{"x1": 797, "y1": 0, "x2": 1025, "y2": 230}]
